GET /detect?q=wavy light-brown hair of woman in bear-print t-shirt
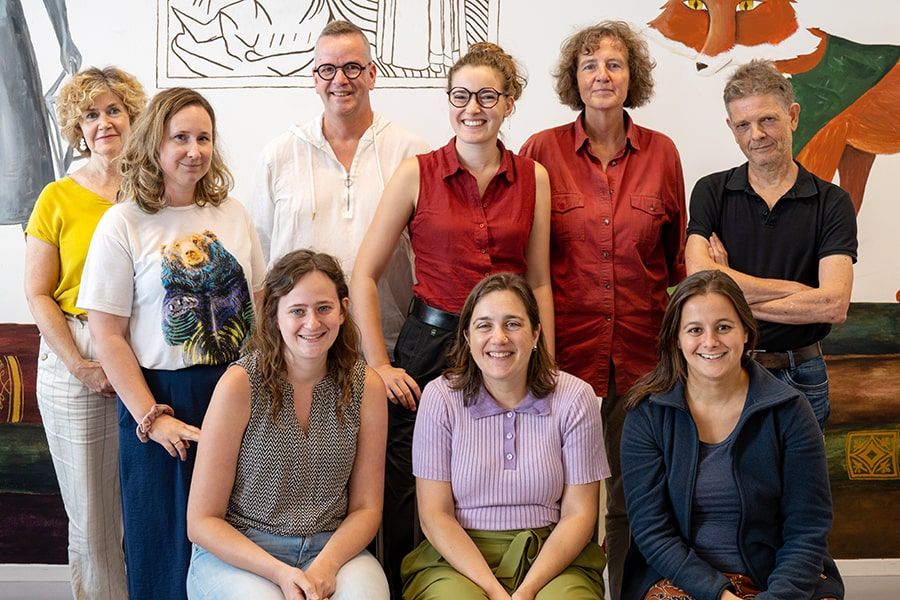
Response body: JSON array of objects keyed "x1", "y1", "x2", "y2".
[{"x1": 119, "y1": 88, "x2": 234, "y2": 214}]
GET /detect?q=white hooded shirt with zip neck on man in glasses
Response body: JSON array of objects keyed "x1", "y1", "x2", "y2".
[{"x1": 245, "y1": 114, "x2": 429, "y2": 356}]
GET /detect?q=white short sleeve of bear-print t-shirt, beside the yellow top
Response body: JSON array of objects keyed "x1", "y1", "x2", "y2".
[{"x1": 77, "y1": 205, "x2": 134, "y2": 317}]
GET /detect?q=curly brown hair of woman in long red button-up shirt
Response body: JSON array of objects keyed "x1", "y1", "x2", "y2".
[{"x1": 553, "y1": 21, "x2": 656, "y2": 111}]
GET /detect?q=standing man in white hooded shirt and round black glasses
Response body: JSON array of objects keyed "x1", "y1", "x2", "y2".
[{"x1": 247, "y1": 21, "x2": 429, "y2": 356}]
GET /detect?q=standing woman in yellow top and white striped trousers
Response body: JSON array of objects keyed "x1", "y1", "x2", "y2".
[{"x1": 25, "y1": 67, "x2": 147, "y2": 600}]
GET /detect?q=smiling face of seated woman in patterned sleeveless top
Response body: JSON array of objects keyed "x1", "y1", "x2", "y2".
[{"x1": 277, "y1": 271, "x2": 349, "y2": 363}]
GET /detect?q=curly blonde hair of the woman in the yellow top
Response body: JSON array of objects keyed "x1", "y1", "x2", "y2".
[{"x1": 56, "y1": 66, "x2": 147, "y2": 156}]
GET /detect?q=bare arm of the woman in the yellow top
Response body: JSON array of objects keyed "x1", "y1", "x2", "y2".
[{"x1": 25, "y1": 235, "x2": 115, "y2": 397}]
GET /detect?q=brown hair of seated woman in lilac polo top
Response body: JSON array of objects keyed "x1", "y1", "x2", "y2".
[{"x1": 444, "y1": 273, "x2": 559, "y2": 406}]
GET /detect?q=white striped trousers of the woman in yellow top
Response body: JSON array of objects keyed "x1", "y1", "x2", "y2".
[{"x1": 37, "y1": 317, "x2": 128, "y2": 600}]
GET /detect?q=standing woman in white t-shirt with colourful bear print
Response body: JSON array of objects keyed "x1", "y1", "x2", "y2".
[{"x1": 78, "y1": 88, "x2": 264, "y2": 600}]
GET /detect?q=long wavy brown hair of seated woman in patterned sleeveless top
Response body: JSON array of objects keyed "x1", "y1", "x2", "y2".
[{"x1": 249, "y1": 250, "x2": 359, "y2": 422}]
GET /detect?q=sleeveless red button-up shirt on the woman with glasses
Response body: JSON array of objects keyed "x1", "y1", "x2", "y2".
[{"x1": 409, "y1": 138, "x2": 535, "y2": 313}]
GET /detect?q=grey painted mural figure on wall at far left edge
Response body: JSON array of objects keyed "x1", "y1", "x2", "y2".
[{"x1": 0, "y1": 0, "x2": 81, "y2": 225}]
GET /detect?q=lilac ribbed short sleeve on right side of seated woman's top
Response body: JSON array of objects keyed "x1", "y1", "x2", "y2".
[{"x1": 554, "y1": 375, "x2": 610, "y2": 485}]
